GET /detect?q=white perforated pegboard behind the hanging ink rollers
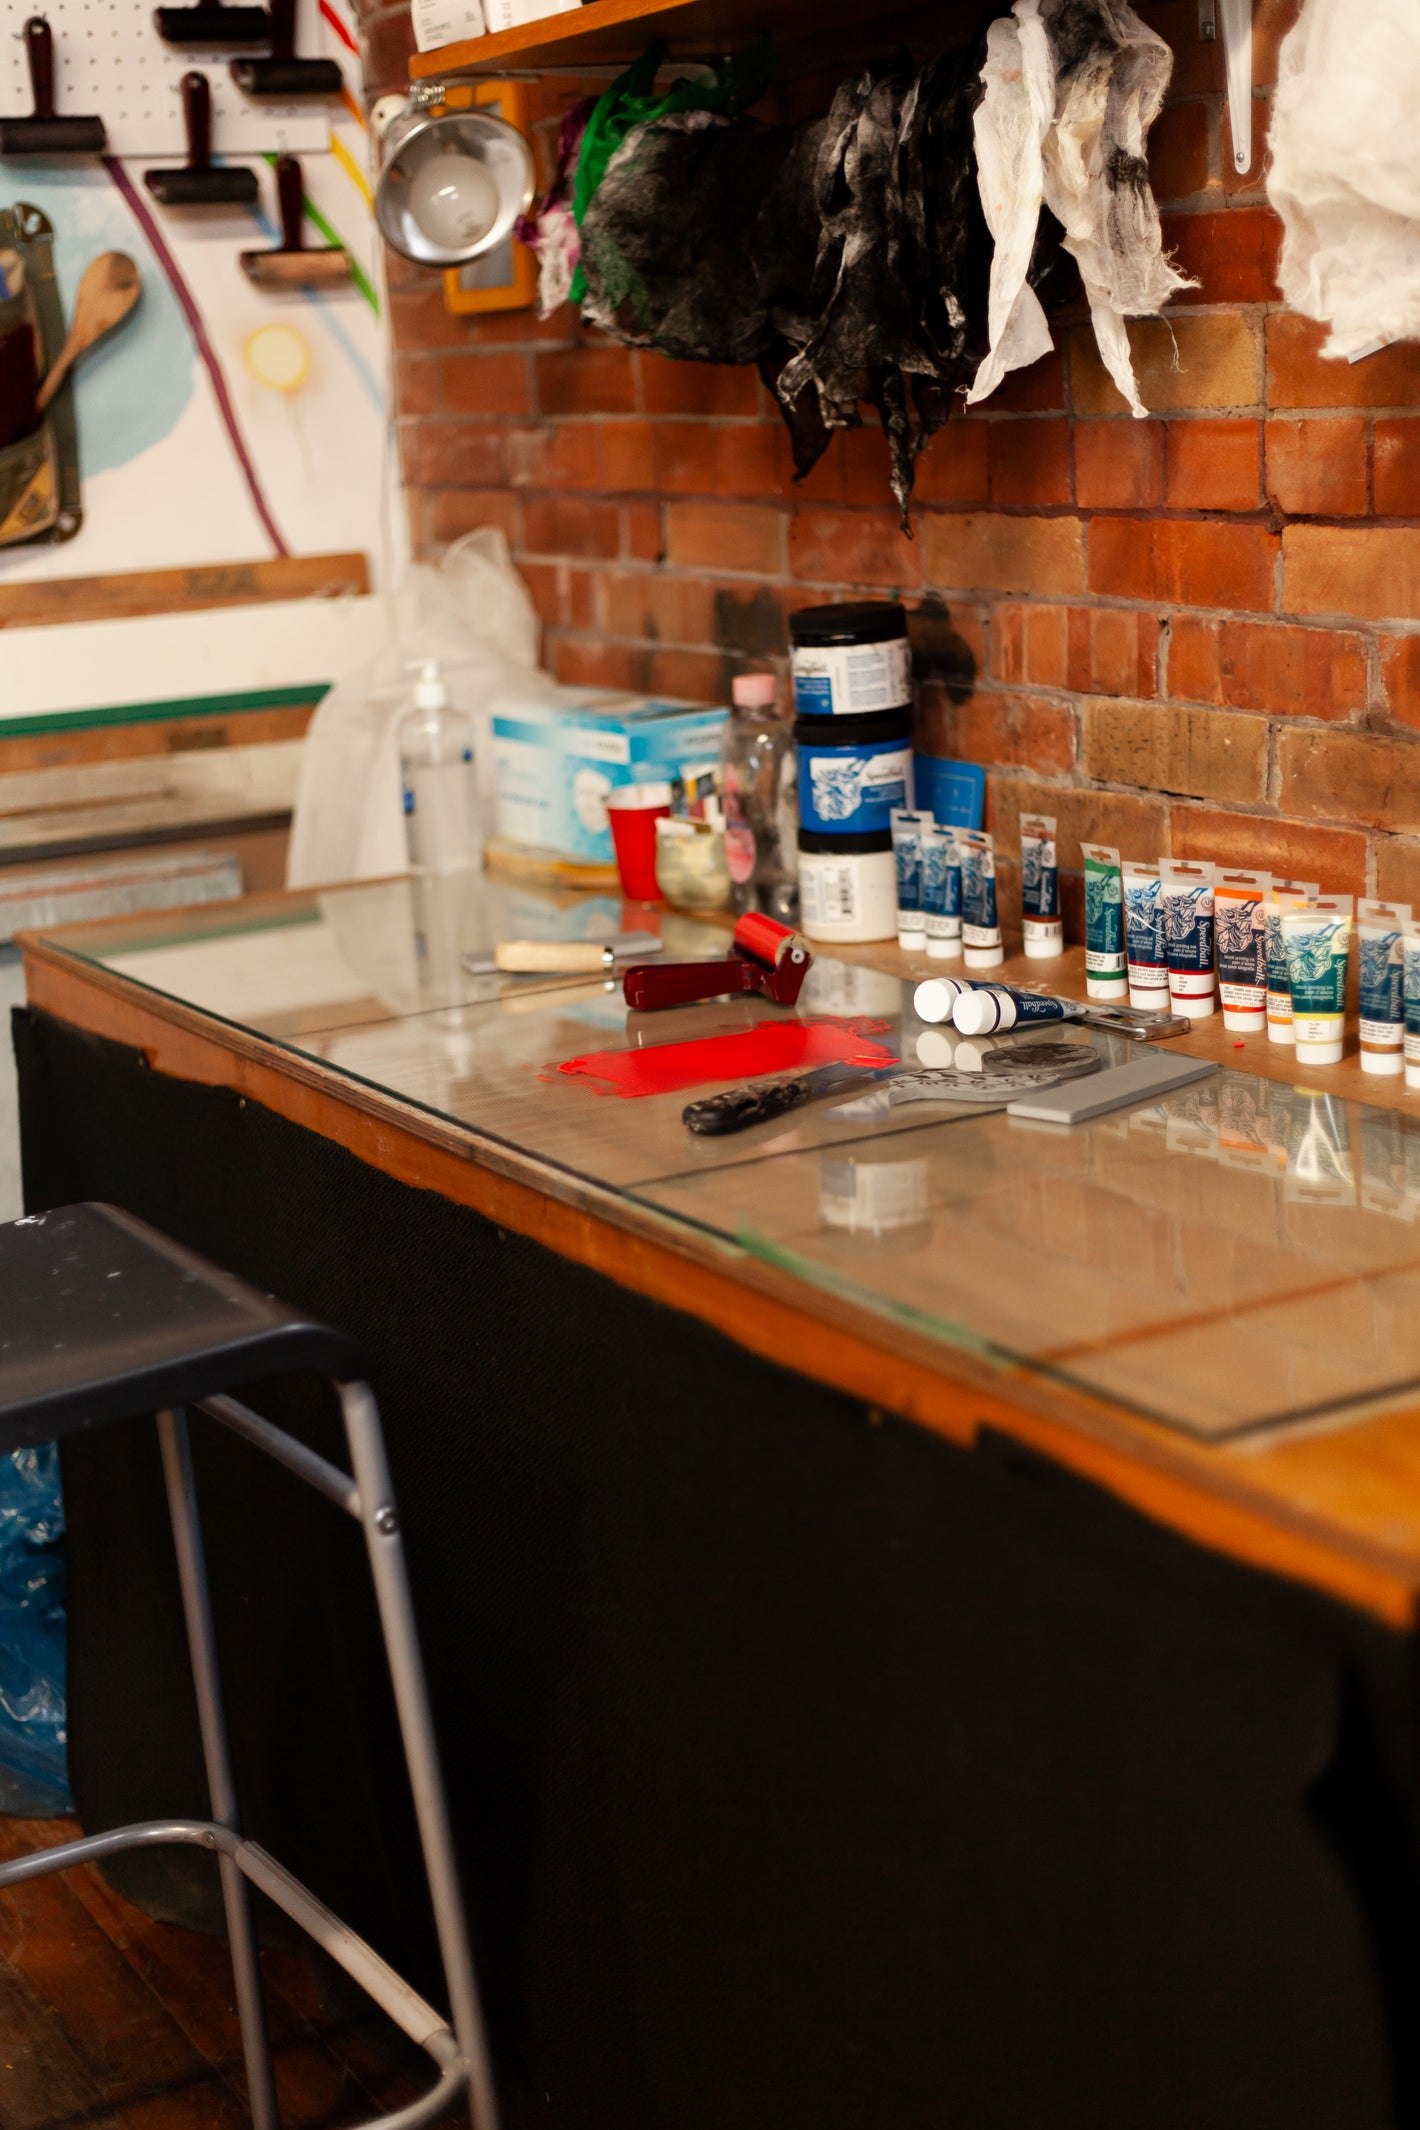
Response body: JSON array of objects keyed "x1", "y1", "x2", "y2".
[{"x1": 0, "y1": 0, "x2": 336, "y2": 155}]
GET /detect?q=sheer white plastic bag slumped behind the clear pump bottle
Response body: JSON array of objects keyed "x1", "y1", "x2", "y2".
[{"x1": 285, "y1": 541, "x2": 540, "y2": 888}]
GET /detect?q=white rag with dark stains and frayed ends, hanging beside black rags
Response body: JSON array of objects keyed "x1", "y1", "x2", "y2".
[{"x1": 967, "y1": 0, "x2": 1196, "y2": 420}]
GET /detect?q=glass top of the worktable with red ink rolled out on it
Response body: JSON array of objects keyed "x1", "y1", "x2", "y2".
[{"x1": 33, "y1": 878, "x2": 1420, "y2": 1440}]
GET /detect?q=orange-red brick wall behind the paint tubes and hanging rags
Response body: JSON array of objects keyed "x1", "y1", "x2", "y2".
[{"x1": 368, "y1": 0, "x2": 1420, "y2": 932}]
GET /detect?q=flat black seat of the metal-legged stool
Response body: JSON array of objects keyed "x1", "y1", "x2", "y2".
[{"x1": 0, "y1": 1206, "x2": 368, "y2": 1455}]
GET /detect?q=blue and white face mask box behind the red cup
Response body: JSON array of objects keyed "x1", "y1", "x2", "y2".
[{"x1": 492, "y1": 697, "x2": 728, "y2": 865}]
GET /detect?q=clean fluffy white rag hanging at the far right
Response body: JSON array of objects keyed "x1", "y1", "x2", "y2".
[{"x1": 1267, "y1": 0, "x2": 1420, "y2": 360}]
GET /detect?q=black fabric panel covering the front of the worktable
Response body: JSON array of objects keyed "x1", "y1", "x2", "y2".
[{"x1": 15, "y1": 1014, "x2": 1420, "y2": 2130}]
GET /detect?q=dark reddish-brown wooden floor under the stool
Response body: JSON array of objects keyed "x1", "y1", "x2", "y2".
[{"x1": 0, "y1": 1817, "x2": 468, "y2": 2130}]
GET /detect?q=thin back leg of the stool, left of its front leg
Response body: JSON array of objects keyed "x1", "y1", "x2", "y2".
[{"x1": 158, "y1": 1408, "x2": 281, "y2": 2130}]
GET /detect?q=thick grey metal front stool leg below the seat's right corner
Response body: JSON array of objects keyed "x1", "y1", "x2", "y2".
[{"x1": 336, "y1": 1382, "x2": 498, "y2": 2130}]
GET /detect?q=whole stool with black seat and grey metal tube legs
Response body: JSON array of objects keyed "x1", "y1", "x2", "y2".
[{"x1": 0, "y1": 1206, "x2": 496, "y2": 2130}]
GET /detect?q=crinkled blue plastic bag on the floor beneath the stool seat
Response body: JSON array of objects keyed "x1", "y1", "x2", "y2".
[{"x1": 0, "y1": 1442, "x2": 72, "y2": 1819}]
